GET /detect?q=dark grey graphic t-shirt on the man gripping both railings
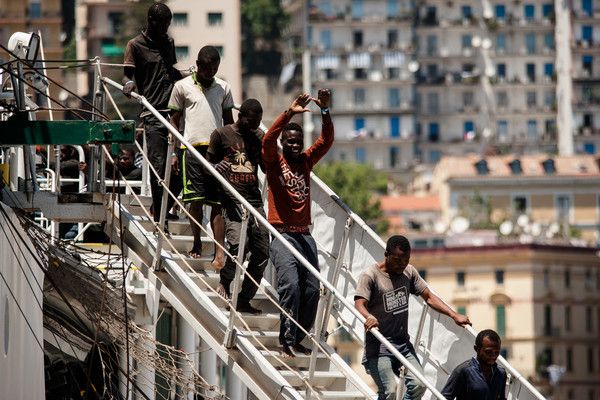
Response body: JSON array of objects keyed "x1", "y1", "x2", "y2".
[{"x1": 354, "y1": 264, "x2": 427, "y2": 358}]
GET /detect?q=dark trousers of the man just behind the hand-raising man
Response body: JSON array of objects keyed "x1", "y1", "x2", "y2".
[{"x1": 219, "y1": 206, "x2": 269, "y2": 303}]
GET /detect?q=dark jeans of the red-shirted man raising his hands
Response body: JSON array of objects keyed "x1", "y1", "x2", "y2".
[{"x1": 271, "y1": 233, "x2": 319, "y2": 346}]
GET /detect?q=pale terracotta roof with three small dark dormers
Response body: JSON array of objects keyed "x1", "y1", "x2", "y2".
[{"x1": 436, "y1": 154, "x2": 600, "y2": 178}]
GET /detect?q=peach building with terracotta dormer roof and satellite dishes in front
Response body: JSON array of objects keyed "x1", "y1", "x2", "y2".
[{"x1": 430, "y1": 154, "x2": 600, "y2": 245}]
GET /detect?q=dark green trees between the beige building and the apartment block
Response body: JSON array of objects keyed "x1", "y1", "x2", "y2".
[{"x1": 241, "y1": 0, "x2": 289, "y2": 76}]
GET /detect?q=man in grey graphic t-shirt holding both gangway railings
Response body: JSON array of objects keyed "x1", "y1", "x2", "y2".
[{"x1": 354, "y1": 235, "x2": 470, "y2": 400}]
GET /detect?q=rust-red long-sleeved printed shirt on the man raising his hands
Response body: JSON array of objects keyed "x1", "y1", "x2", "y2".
[{"x1": 262, "y1": 113, "x2": 333, "y2": 232}]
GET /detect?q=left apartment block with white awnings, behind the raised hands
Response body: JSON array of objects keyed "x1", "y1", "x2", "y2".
[{"x1": 284, "y1": 0, "x2": 415, "y2": 171}]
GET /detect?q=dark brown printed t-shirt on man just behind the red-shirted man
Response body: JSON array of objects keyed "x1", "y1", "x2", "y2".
[{"x1": 208, "y1": 124, "x2": 263, "y2": 207}]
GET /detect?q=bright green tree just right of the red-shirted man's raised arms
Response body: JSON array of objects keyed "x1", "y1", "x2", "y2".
[{"x1": 315, "y1": 161, "x2": 388, "y2": 234}]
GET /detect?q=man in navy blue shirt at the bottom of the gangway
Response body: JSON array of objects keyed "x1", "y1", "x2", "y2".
[{"x1": 442, "y1": 329, "x2": 506, "y2": 400}]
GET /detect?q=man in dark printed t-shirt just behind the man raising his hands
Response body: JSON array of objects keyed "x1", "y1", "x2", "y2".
[{"x1": 208, "y1": 99, "x2": 269, "y2": 314}]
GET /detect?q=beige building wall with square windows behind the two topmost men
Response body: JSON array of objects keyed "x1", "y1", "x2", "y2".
[{"x1": 167, "y1": 0, "x2": 242, "y2": 103}]
